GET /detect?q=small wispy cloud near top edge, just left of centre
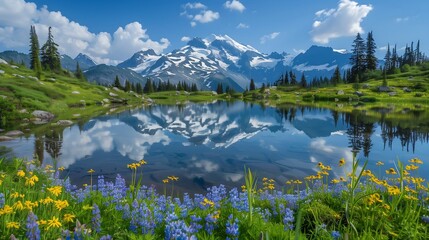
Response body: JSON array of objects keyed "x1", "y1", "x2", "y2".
[{"x1": 180, "y1": 2, "x2": 220, "y2": 27}]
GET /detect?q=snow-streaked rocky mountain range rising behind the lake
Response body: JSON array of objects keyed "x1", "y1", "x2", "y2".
[{"x1": 118, "y1": 35, "x2": 350, "y2": 91}]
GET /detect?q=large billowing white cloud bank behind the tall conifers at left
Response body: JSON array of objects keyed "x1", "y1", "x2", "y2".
[{"x1": 0, "y1": 0, "x2": 171, "y2": 64}]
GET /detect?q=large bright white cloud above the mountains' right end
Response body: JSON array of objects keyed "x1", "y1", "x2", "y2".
[{"x1": 311, "y1": 0, "x2": 372, "y2": 44}]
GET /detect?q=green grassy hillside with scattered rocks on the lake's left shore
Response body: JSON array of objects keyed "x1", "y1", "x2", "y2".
[{"x1": 0, "y1": 61, "x2": 142, "y2": 125}]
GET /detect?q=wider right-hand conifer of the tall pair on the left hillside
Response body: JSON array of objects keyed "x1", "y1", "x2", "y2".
[{"x1": 42, "y1": 27, "x2": 61, "y2": 72}]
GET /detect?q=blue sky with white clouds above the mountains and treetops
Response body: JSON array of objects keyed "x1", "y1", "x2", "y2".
[{"x1": 0, "y1": 0, "x2": 429, "y2": 64}]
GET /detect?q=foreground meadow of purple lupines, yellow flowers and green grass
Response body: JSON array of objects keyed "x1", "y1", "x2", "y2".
[{"x1": 0, "y1": 158, "x2": 429, "y2": 239}]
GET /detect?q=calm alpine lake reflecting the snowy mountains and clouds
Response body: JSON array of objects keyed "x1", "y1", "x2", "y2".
[{"x1": 0, "y1": 101, "x2": 429, "y2": 194}]
